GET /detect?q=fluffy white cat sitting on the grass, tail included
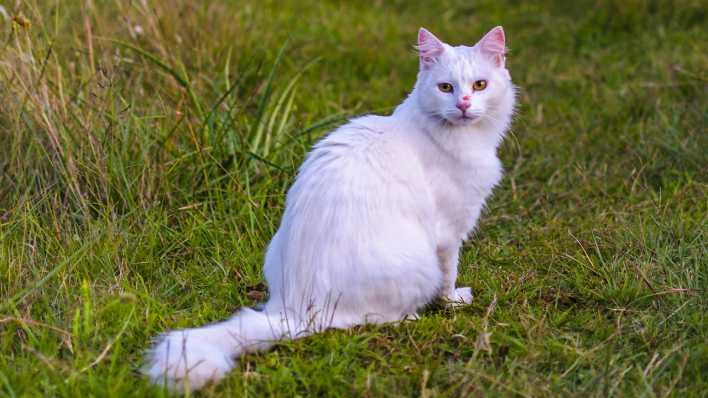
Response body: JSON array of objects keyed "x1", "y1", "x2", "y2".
[{"x1": 145, "y1": 27, "x2": 515, "y2": 389}]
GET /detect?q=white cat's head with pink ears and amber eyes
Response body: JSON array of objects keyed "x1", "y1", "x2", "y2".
[{"x1": 416, "y1": 26, "x2": 513, "y2": 126}]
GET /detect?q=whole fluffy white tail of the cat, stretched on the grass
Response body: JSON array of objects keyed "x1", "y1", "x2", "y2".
[{"x1": 143, "y1": 308, "x2": 303, "y2": 391}]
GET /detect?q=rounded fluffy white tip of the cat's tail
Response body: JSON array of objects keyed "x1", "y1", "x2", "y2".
[{"x1": 143, "y1": 331, "x2": 234, "y2": 391}]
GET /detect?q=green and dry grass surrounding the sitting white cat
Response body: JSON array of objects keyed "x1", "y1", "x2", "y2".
[{"x1": 0, "y1": 0, "x2": 708, "y2": 397}]
